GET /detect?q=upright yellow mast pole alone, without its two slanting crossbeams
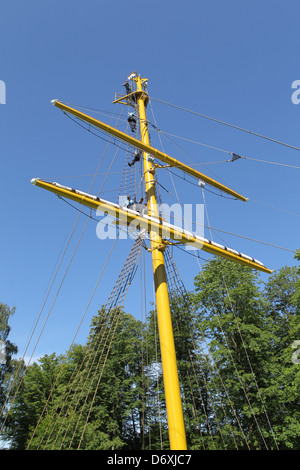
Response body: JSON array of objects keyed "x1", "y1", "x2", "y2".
[{"x1": 134, "y1": 76, "x2": 187, "y2": 450}]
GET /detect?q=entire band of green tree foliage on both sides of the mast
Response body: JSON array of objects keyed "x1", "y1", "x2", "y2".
[{"x1": 5, "y1": 254, "x2": 300, "y2": 450}]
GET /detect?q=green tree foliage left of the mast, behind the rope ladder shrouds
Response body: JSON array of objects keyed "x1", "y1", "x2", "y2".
[{"x1": 19, "y1": 308, "x2": 145, "y2": 450}]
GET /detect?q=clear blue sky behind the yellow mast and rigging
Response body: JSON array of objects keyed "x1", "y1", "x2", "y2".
[{"x1": 0, "y1": 0, "x2": 300, "y2": 357}]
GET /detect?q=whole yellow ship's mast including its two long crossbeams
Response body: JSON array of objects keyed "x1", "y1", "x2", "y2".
[{"x1": 32, "y1": 74, "x2": 271, "y2": 450}]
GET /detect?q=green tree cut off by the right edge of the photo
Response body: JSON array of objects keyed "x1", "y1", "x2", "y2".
[{"x1": 263, "y1": 266, "x2": 300, "y2": 450}]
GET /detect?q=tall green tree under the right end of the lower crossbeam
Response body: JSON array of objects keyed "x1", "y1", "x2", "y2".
[{"x1": 195, "y1": 258, "x2": 271, "y2": 449}]
